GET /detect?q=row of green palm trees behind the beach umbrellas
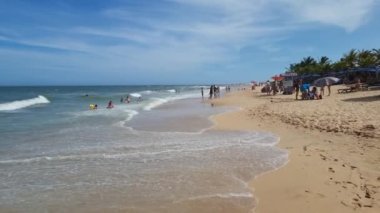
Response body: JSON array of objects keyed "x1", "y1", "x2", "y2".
[{"x1": 286, "y1": 49, "x2": 380, "y2": 75}]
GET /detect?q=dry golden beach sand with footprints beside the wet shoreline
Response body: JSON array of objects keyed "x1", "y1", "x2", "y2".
[{"x1": 212, "y1": 86, "x2": 380, "y2": 213}]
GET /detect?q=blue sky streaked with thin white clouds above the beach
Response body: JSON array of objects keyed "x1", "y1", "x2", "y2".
[{"x1": 0, "y1": 0, "x2": 380, "y2": 85}]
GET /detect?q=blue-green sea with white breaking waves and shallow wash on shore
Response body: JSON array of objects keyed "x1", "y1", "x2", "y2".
[{"x1": 0, "y1": 85, "x2": 287, "y2": 212}]
